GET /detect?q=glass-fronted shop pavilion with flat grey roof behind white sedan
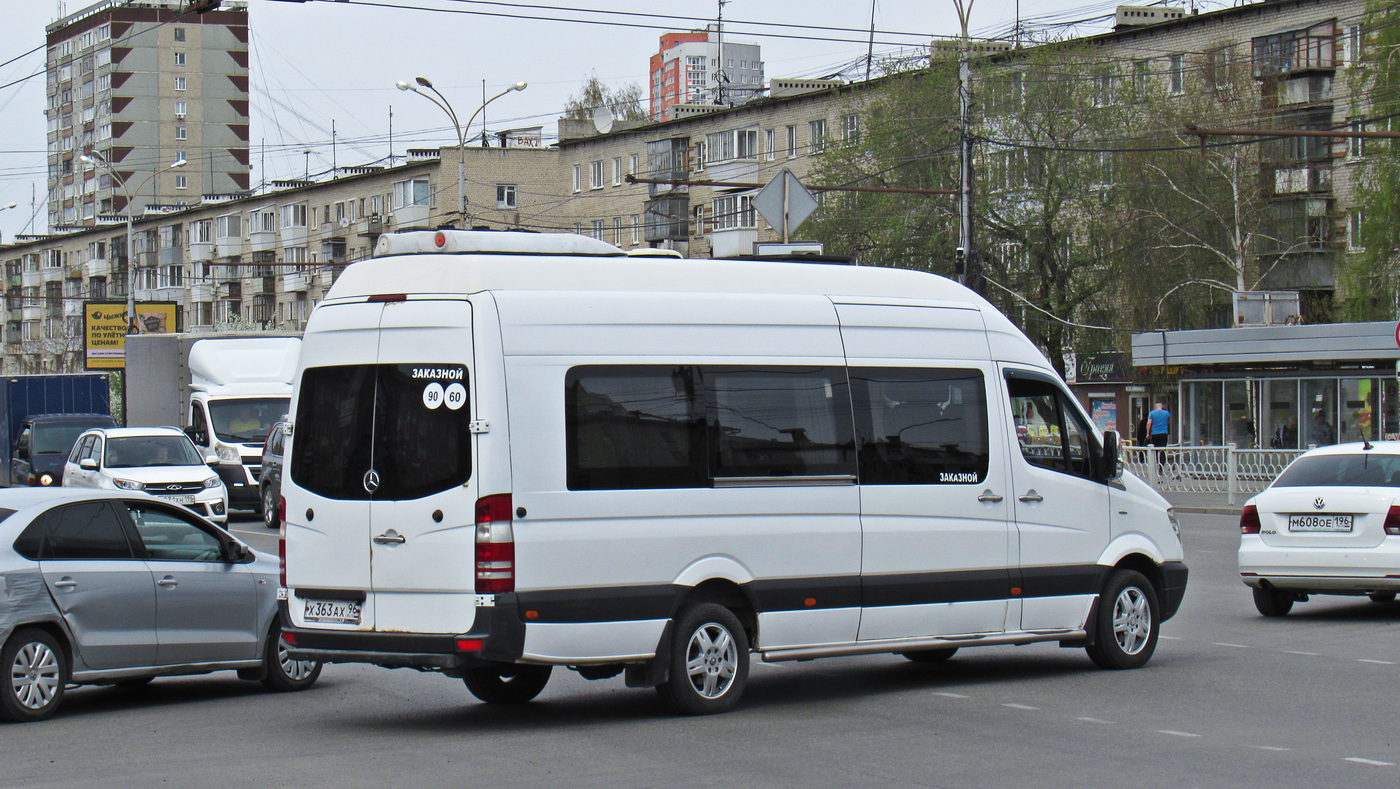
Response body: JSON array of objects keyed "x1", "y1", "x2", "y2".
[{"x1": 1133, "y1": 322, "x2": 1400, "y2": 449}]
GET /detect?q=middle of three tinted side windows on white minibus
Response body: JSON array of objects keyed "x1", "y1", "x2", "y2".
[{"x1": 701, "y1": 367, "x2": 855, "y2": 477}]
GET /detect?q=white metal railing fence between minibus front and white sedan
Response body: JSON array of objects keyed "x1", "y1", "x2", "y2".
[{"x1": 1121, "y1": 443, "x2": 1306, "y2": 504}]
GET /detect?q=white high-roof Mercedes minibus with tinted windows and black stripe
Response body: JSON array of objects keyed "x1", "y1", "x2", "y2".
[{"x1": 281, "y1": 229, "x2": 1187, "y2": 713}]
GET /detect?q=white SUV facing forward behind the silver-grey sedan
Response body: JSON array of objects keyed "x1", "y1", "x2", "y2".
[{"x1": 63, "y1": 428, "x2": 228, "y2": 523}]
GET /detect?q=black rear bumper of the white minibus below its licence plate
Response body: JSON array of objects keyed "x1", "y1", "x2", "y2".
[{"x1": 277, "y1": 595, "x2": 525, "y2": 674}]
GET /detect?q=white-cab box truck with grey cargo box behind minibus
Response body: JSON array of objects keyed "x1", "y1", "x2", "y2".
[{"x1": 126, "y1": 333, "x2": 301, "y2": 512}]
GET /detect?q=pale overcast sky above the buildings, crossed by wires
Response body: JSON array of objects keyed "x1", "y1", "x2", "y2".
[{"x1": 0, "y1": 0, "x2": 1233, "y2": 242}]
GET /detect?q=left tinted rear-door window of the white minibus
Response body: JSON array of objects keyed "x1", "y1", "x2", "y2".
[{"x1": 290, "y1": 365, "x2": 375, "y2": 499}]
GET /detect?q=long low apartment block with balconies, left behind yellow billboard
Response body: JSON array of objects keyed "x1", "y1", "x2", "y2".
[{"x1": 0, "y1": 145, "x2": 563, "y2": 375}]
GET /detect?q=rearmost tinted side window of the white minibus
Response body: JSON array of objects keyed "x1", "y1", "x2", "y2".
[{"x1": 564, "y1": 365, "x2": 710, "y2": 491}]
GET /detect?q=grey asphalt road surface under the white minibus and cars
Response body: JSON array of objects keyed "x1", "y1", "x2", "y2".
[{"x1": 0, "y1": 515, "x2": 1400, "y2": 789}]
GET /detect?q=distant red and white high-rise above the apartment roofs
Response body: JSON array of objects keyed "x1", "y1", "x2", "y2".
[{"x1": 650, "y1": 25, "x2": 763, "y2": 120}]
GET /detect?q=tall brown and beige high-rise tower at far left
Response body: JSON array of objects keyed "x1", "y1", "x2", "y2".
[{"x1": 45, "y1": 0, "x2": 249, "y2": 229}]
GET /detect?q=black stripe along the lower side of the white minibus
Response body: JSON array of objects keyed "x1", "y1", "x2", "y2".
[{"x1": 517, "y1": 564, "x2": 1112, "y2": 624}]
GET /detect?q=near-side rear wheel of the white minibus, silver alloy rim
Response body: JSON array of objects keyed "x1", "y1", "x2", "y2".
[{"x1": 657, "y1": 603, "x2": 749, "y2": 715}]
